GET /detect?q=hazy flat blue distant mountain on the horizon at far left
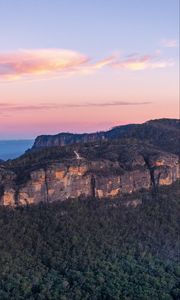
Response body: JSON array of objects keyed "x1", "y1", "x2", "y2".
[{"x1": 0, "y1": 140, "x2": 33, "y2": 160}]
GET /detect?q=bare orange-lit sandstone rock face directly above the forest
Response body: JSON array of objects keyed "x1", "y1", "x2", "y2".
[{"x1": 0, "y1": 153, "x2": 180, "y2": 206}]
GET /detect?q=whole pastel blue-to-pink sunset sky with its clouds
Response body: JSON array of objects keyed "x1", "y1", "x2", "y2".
[{"x1": 0, "y1": 0, "x2": 179, "y2": 140}]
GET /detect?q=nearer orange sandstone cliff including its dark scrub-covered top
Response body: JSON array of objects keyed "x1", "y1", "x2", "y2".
[{"x1": 0, "y1": 139, "x2": 180, "y2": 206}]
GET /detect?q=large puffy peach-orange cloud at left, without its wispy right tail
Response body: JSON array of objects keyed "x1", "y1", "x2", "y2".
[{"x1": 0, "y1": 49, "x2": 88, "y2": 79}]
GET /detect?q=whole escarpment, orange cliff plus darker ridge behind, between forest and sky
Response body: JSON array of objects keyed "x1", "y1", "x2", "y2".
[{"x1": 0, "y1": 119, "x2": 180, "y2": 206}]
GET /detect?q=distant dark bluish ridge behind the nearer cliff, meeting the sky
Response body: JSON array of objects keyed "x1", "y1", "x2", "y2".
[{"x1": 32, "y1": 118, "x2": 180, "y2": 154}]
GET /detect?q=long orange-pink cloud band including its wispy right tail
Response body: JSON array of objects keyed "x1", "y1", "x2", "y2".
[{"x1": 0, "y1": 49, "x2": 173, "y2": 80}]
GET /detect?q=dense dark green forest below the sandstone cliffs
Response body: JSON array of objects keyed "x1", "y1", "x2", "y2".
[{"x1": 0, "y1": 182, "x2": 180, "y2": 300}]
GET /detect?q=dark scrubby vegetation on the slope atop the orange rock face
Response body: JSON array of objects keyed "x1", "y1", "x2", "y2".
[{"x1": 4, "y1": 138, "x2": 163, "y2": 172}]
